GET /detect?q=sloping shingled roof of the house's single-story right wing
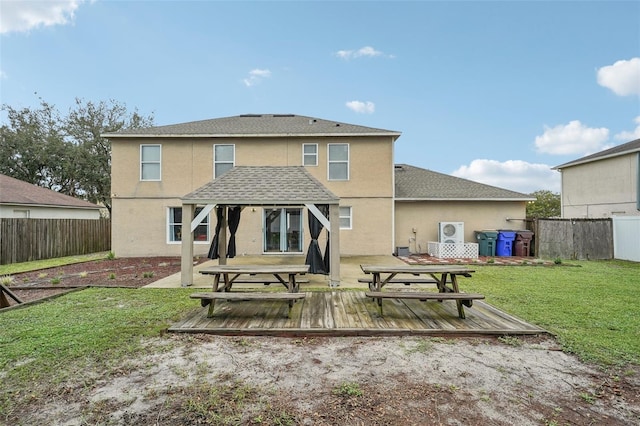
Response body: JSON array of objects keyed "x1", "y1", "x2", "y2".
[{"x1": 395, "y1": 164, "x2": 535, "y2": 201}]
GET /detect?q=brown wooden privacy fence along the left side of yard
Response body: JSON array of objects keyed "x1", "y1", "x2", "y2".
[{"x1": 0, "y1": 219, "x2": 111, "y2": 265}]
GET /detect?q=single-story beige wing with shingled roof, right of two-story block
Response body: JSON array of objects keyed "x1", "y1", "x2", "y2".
[{"x1": 395, "y1": 164, "x2": 535, "y2": 253}]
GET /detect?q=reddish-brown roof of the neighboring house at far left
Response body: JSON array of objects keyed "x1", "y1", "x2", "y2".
[{"x1": 0, "y1": 174, "x2": 102, "y2": 209}]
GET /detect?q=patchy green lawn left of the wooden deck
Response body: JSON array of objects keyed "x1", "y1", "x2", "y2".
[{"x1": 0, "y1": 288, "x2": 199, "y2": 383}]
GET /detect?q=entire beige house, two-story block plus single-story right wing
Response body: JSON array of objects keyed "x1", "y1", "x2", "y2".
[{"x1": 102, "y1": 114, "x2": 533, "y2": 257}]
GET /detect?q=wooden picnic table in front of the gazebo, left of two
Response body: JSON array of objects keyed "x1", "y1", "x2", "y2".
[{"x1": 190, "y1": 265, "x2": 309, "y2": 317}]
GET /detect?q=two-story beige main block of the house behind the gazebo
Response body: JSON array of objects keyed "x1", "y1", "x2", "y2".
[{"x1": 103, "y1": 114, "x2": 400, "y2": 284}]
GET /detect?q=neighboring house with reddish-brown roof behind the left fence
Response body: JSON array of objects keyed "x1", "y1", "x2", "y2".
[{"x1": 0, "y1": 174, "x2": 101, "y2": 219}]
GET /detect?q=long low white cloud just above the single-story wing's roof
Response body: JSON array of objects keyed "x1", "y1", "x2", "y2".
[{"x1": 452, "y1": 159, "x2": 560, "y2": 194}]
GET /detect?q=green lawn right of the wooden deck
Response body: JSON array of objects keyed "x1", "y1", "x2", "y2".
[{"x1": 461, "y1": 261, "x2": 640, "y2": 365}]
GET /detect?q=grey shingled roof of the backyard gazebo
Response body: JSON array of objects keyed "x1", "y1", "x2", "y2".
[{"x1": 182, "y1": 166, "x2": 340, "y2": 205}]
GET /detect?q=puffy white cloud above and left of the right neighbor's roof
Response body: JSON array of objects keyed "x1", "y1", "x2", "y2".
[{"x1": 535, "y1": 120, "x2": 609, "y2": 155}]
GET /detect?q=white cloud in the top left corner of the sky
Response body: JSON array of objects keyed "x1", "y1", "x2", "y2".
[{"x1": 0, "y1": 0, "x2": 84, "y2": 34}]
